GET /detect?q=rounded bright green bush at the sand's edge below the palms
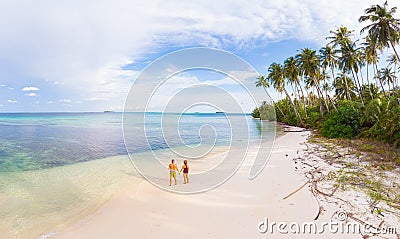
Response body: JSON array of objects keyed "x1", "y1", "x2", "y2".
[{"x1": 322, "y1": 101, "x2": 360, "y2": 138}]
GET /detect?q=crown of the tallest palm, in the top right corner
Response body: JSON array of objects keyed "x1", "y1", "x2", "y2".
[{"x1": 358, "y1": 1, "x2": 400, "y2": 58}]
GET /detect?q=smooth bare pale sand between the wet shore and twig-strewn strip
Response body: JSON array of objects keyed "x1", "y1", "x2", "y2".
[{"x1": 50, "y1": 132, "x2": 359, "y2": 239}]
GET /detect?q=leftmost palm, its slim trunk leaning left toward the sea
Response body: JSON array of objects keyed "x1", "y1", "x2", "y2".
[{"x1": 267, "y1": 62, "x2": 304, "y2": 127}]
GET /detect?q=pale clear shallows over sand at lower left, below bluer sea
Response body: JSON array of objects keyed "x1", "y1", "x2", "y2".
[{"x1": 0, "y1": 156, "x2": 141, "y2": 238}]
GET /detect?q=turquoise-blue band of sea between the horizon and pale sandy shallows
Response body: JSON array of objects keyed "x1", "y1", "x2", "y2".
[{"x1": 0, "y1": 113, "x2": 272, "y2": 172}]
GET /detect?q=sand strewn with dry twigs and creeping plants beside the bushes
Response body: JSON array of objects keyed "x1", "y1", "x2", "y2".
[{"x1": 283, "y1": 135, "x2": 400, "y2": 238}]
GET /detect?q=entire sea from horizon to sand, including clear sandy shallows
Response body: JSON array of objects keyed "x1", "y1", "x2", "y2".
[{"x1": 0, "y1": 112, "x2": 276, "y2": 238}]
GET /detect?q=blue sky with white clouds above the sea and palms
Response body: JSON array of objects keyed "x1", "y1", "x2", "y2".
[{"x1": 0, "y1": 0, "x2": 400, "y2": 112}]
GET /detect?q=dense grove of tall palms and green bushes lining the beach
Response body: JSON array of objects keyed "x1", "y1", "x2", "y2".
[{"x1": 253, "y1": 2, "x2": 400, "y2": 147}]
